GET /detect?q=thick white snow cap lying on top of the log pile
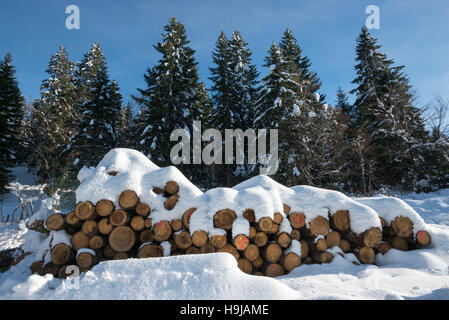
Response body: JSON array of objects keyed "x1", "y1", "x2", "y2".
[{"x1": 76, "y1": 148, "x2": 381, "y2": 235}]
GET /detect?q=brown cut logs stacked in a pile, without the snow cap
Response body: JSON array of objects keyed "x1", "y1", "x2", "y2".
[{"x1": 26, "y1": 181, "x2": 431, "y2": 278}]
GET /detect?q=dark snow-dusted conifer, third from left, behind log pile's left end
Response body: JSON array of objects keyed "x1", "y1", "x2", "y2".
[{"x1": 67, "y1": 43, "x2": 122, "y2": 172}]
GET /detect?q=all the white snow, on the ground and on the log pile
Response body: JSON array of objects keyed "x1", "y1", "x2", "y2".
[{"x1": 0, "y1": 149, "x2": 449, "y2": 300}]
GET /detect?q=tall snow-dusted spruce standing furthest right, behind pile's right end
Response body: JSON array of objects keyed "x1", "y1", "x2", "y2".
[{"x1": 351, "y1": 27, "x2": 429, "y2": 194}]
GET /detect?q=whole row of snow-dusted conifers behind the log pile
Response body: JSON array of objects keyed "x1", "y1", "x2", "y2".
[{"x1": 0, "y1": 18, "x2": 449, "y2": 195}]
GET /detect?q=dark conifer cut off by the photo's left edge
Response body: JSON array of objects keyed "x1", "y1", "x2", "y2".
[{"x1": 0, "y1": 53, "x2": 25, "y2": 193}]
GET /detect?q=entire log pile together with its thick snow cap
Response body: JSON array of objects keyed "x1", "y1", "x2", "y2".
[{"x1": 23, "y1": 149, "x2": 431, "y2": 277}]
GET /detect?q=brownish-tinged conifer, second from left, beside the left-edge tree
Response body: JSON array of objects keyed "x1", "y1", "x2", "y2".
[{"x1": 27, "y1": 46, "x2": 77, "y2": 183}]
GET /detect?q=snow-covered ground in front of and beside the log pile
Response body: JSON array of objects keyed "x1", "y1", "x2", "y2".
[{"x1": 0, "y1": 162, "x2": 449, "y2": 299}]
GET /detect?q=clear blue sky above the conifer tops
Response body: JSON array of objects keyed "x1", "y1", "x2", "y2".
[{"x1": 0, "y1": 0, "x2": 449, "y2": 106}]
